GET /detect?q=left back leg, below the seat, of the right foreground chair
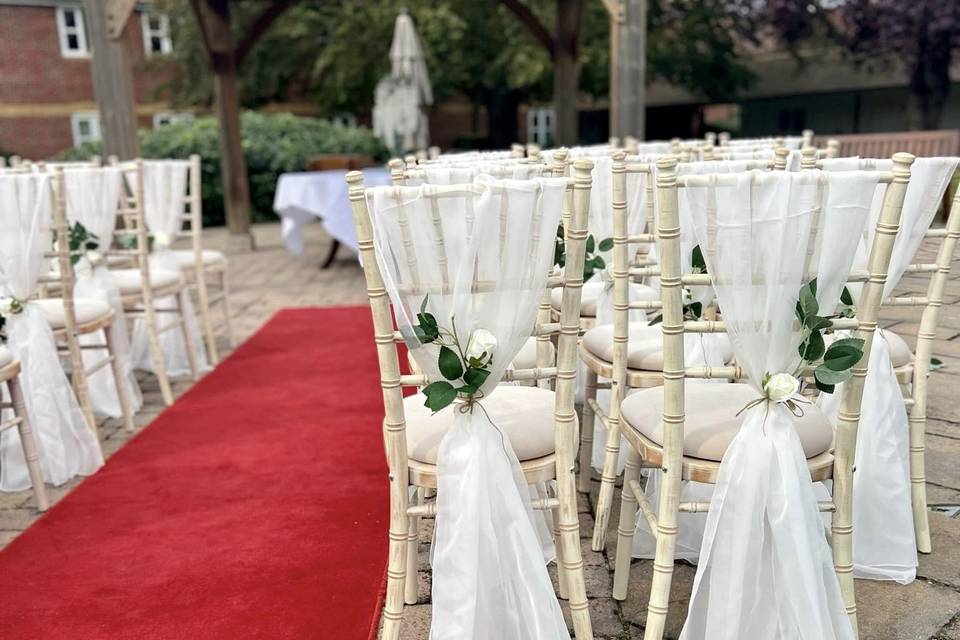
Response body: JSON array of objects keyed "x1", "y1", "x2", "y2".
[{"x1": 643, "y1": 461, "x2": 682, "y2": 640}]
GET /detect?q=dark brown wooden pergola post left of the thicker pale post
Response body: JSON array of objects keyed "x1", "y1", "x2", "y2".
[{"x1": 553, "y1": 0, "x2": 583, "y2": 146}]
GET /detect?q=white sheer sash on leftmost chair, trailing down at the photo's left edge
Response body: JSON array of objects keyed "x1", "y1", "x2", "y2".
[{"x1": 0, "y1": 174, "x2": 103, "y2": 491}]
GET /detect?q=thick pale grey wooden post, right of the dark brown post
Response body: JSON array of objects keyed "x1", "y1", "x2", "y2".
[{"x1": 603, "y1": 0, "x2": 647, "y2": 140}]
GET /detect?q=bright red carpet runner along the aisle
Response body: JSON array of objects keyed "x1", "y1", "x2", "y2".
[{"x1": 0, "y1": 307, "x2": 388, "y2": 640}]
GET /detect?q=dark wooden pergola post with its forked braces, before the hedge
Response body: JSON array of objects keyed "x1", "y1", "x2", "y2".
[{"x1": 184, "y1": 0, "x2": 296, "y2": 243}]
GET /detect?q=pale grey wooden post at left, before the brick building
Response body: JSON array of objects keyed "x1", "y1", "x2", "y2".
[{"x1": 83, "y1": 0, "x2": 140, "y2": 160}]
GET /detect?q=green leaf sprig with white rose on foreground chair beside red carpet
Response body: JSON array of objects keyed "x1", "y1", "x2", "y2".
[{"x1": 413, "y1": 296, "x2": 497, "y2": 413}]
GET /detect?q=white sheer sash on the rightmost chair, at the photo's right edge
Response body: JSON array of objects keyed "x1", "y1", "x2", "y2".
[{"x1": 821, "y1": 158, "x2": 960, "y2": 584}]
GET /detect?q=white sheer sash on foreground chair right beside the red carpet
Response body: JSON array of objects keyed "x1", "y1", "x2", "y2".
[{"x1": 367, "y1": 177, "x2": 569, "y2": 640}]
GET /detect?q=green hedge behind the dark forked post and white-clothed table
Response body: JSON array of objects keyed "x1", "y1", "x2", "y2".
[{"x1": 58, "y1": 111, "x2": 388, "y2": 226}]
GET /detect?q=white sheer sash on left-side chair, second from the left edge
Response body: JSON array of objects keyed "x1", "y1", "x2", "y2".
[{"x1": 63, "y1": 167, "x2": 143, "y2": 418}]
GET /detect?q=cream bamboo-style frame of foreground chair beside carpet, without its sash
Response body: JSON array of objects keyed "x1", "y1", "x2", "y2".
[{"x1": 347, "y1": 160, "x2": 592, "y2": 640}]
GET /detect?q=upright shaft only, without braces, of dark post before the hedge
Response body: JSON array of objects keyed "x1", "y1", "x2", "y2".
[{"x1": 207, "y1": 0, "x2": 252, "y2": 247}]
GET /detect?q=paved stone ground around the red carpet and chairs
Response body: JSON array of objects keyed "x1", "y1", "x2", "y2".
[{"x1": 0, "y1": 224, "x2": 960, "y2": 640}]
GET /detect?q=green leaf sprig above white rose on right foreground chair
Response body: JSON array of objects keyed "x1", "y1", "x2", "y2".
[{"x1": 796, "y1": 278, "x2": 863, "y2": 393}]
